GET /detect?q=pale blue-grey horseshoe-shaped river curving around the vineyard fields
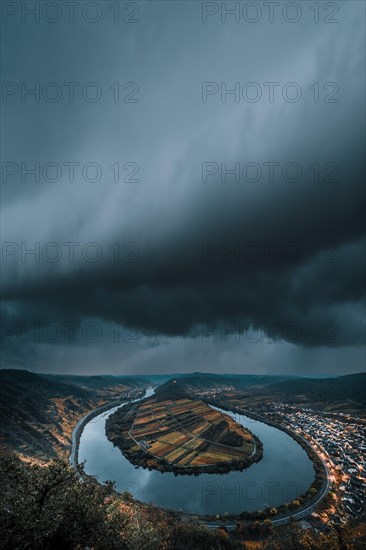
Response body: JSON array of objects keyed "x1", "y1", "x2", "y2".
[{"x1": 79, "y1": 390, "x2": 315, "y2": 514}]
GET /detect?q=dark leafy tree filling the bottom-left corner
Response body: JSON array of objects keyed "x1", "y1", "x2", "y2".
[{"x1": 0, "y1": 458, "x2": 127, "y2": 549}]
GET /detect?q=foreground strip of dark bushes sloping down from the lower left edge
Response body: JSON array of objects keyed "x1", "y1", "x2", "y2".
[{"x1": 0, "y1": 455, "x2": 242, "y2": 550}]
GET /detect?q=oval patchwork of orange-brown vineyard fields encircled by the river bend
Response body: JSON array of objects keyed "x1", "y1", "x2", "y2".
[{"x1": 106, "y1": 398, "x2": 262, "y2": 473}]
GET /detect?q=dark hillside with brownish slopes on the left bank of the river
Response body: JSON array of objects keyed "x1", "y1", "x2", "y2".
[{"x1": 0, "y1": 369, "x2": 149, "y2": 460}]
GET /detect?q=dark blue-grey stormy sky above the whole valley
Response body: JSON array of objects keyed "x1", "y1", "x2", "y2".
[{"x1": 1, "y1": 0, "x2": 365, "y2": 375}]
